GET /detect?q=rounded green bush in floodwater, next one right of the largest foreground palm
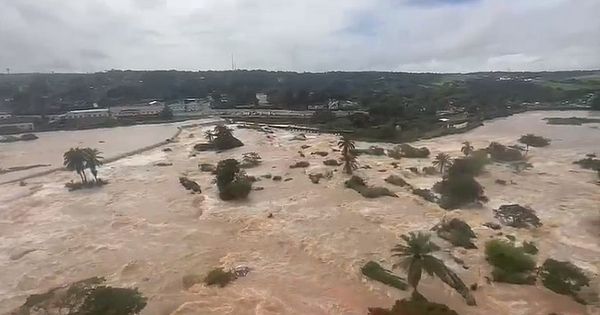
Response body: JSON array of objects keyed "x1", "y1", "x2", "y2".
[{"x1": 485, "y1": 240, "x2": 536, "y2": 284}]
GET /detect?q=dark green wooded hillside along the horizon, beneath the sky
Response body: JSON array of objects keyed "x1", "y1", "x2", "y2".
[{"x1": 0, "y1": 70, "x2": 600, "y2": 115}]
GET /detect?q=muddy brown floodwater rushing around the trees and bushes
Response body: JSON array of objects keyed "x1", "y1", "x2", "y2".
[{"x1": 0, "y1": 112, "x2": 600, "y2": 315}]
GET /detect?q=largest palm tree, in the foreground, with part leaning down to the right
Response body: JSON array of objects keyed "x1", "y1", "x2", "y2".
[{"x1": 392, "y1": 232, "x2": 475, "y2": 305}]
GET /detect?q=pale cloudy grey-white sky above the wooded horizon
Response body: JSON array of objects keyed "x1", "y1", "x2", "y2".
[{"x1": 0, "y1": 0, "x2": 600, "y2": 73}]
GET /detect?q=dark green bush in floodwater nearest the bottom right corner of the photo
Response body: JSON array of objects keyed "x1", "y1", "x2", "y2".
[{"x1": 540, "y1": 258, "x2": 590, "y2": 304}]
